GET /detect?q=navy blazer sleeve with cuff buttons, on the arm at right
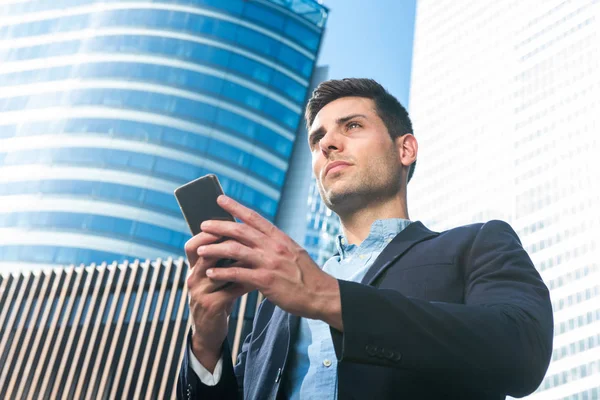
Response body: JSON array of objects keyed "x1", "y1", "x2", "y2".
[{"x1": 331, "y1": 221, "x2": 553, "y2": 397}]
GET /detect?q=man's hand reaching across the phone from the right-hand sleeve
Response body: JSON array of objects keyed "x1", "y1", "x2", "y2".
[{"x1": 197, "y1": 195, "x2": 343, "y2": 331}]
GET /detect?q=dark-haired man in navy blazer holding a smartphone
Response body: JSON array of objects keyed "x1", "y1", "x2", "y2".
[{"x1": 177, "y1": 79, "x2": 553, "y2": 400}]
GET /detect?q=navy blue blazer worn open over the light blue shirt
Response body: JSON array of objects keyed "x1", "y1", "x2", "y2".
[{"x1": 177, "y1": 221, "x2": 553, "y2": 400}]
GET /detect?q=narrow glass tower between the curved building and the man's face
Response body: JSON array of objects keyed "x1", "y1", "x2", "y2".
[{"x1": 276, "y1": 66, "x2": 339, "y2": 265}]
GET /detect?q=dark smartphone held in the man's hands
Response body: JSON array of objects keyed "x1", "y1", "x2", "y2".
[{"x1": 175, "y1": 174, "x2": 235, "y2": 276}]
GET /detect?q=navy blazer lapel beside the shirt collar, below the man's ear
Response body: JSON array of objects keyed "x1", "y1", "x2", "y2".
[{"x1": 361, "y1": 221, "x2": 438, "y2": 285}]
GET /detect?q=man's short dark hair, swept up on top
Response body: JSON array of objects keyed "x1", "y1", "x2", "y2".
[{"x1": 304, "y1": 78, "x2": 417, "y2": 182}]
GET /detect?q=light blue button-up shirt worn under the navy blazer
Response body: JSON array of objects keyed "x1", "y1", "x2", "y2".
[{"x1": 285, "y1": 218, "x2": 411, "y2": 400}]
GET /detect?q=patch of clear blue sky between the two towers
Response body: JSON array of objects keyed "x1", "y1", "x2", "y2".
[{"x1": 317, "y1": 0, "x2": 417, "y2": 109}]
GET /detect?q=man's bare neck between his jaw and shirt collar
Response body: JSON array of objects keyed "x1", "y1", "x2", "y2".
[{"x1": 340, "y1": 197, "x2": 409, "y2": 246}]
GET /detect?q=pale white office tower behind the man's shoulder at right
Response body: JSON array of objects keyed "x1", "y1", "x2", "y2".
[{"x1": 408, "y1": 0, "x2": 600, "y2": 399}]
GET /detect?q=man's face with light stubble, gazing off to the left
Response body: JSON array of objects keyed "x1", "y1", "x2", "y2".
[{"x1": 308, "y1": 97, "x2": 402, "y2": 214}]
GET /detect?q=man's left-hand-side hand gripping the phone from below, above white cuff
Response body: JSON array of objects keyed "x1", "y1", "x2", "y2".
[{"x1": 185, "y1": 232, "x2": 254, "y2": 372}]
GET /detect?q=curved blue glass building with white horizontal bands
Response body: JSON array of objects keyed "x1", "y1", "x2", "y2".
[{"x1": 0, "y1": 0, "x2": 327, "y2": 268}]
